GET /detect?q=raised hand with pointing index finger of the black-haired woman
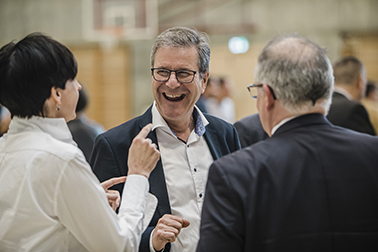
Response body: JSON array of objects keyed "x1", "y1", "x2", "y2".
[{"x1": 127, "y1": 124, "x2": 160, "y2": 178}]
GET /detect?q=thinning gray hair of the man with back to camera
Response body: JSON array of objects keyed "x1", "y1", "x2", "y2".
[{"x1": 255, "y1": 35, "x2": 334, "y2": 113}]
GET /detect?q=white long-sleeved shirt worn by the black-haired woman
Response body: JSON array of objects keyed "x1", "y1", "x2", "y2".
[{"x1": 0, "y1": 117, "x2": 156, "y2": 252}]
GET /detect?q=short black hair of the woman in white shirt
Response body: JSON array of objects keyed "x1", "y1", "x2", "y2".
[{"x1": 0, "y1": 33, "x2": 77, "y2": 118}]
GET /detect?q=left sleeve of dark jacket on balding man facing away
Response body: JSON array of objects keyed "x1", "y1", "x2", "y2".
[{"x1": 196, "y1": 161, "x2": 244, "y2": 252}]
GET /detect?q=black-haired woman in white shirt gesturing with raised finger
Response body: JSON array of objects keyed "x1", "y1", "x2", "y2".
[{"x1": 0, "y1": 33, "x2": 159, "y2": 252}]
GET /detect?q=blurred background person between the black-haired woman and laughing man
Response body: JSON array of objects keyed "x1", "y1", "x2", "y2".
[{"x1": 67, "y1": 86, "x2": 105, "y2": 161}]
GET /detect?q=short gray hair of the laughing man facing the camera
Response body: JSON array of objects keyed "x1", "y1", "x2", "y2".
[{"x1": 150, "y1": 27, "x2": 210, "y2": 78}]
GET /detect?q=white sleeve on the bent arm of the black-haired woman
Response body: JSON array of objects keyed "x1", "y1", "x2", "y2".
[{"x1": 55, "y1": 156, "x2": 149, "y2": 252}]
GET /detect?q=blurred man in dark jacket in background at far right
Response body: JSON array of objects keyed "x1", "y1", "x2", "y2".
[{"x1": 327, "y1": 56, "x2": 375, "y2": 136}]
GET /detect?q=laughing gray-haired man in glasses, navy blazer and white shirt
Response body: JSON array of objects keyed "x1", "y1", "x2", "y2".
[{"x1": 90, "y1": 27, "x2": 240, "y2": 252}]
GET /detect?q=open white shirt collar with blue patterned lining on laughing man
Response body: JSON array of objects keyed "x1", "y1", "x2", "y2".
[{"x1": 152, "y1": 101, "x2": 209, "y2": 136}]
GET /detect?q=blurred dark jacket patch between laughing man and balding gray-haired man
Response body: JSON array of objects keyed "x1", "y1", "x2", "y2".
[{"x1": 234, "y1": 113, "x2": 269, "y2": 148}]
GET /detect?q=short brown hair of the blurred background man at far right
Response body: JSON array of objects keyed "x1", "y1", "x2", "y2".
[{"x1": 333, "y1": 56, "x2": 364, "y2": 85}]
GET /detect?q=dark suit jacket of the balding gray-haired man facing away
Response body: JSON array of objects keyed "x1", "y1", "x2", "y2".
[{"x1": 197, "y1": 114, "x2": 378, "y2": 252}]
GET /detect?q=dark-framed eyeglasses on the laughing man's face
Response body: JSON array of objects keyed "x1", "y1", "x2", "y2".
[{"x1": 151, "y1": 68, "x2": 197, "y2": 84}]
